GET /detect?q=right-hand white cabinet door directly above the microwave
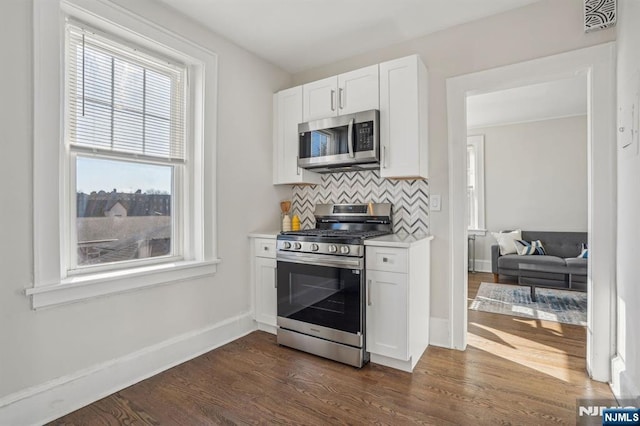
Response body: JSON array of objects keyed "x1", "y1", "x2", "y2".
[{"x1": 338, "y1": 64, "x2": 380, "y2": 115}]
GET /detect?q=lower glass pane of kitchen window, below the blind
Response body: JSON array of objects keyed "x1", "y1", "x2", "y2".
[{"x1": 75, "y1": 155, "x2": 172, "y2": 269}]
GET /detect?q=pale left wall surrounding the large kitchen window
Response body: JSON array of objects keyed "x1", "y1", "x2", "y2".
[{"x1": 0, "y1": 0, "x2": 291, "y2": 412}]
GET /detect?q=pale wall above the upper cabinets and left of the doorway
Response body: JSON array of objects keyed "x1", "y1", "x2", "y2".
[{"x1": 294, "y1": 0, "x2": 615, "y2": 328}]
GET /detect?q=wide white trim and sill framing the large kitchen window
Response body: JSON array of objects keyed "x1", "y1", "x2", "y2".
[{"x1": 26, "y1": 0, "x2": 220, "y2": 309}]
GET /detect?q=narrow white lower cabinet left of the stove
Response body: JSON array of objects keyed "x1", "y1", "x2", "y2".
[{"x1": 251, "y1": 238, "x2": 278, "y2": 334}]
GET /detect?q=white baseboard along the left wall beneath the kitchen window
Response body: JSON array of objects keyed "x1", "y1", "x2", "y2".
[{"x1": 0, "y1": 313, "x2": 256, "y2": 425}]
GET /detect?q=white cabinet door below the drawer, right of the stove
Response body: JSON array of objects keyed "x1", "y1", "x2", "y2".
[{"x1": 366, "y1": 270, "x2": 409, "y2": 361}]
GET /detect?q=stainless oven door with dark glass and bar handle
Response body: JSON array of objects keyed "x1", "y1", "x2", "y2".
[{"x1": 277, "y1": 252, "x2": 364, "y2": 347}]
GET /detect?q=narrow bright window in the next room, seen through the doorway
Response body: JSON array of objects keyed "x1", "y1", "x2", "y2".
[{"x1": 467, "y1": 135, "x2": 485, "y2": 231}]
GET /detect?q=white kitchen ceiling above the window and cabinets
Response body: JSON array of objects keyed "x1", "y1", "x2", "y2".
[{"x1": 158, "y1": 0, "x2": 538, "y2": 73}]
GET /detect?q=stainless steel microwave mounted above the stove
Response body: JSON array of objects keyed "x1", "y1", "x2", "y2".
[{"x1": 298, "y1": 109, "x2": 380, "y2": 173}]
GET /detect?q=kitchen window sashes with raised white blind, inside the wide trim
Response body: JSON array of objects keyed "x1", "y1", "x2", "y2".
[{"x1": 64, "y1": 23, "x2": 189, "y2": 271}]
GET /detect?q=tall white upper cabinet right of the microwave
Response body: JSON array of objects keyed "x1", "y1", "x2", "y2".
[{"x1": 380, "y1": 55, "x2": 429, "y2": 178}]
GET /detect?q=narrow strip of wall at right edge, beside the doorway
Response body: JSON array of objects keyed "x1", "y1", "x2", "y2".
[{"x1": 613, "y1": 0, "x2": 640, "y2": 397}]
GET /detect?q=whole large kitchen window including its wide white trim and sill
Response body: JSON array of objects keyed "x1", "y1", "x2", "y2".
[{"x1": 26, "y1": 0, "x2": 219, "y2": 308}]
